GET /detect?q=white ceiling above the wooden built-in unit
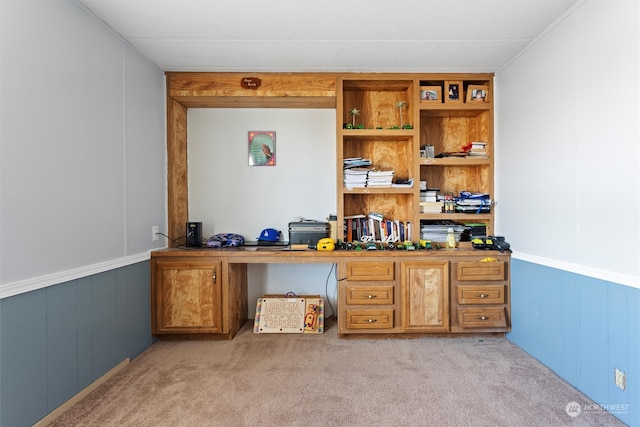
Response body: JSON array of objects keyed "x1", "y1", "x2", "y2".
[{"x1": 78, "y1": 0, "x2": 584, "y2": 72}]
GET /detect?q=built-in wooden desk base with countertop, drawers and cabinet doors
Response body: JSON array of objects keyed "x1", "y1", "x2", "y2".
[{"x1": 151, "y1": 246, "x2": 511, "y2": 339}]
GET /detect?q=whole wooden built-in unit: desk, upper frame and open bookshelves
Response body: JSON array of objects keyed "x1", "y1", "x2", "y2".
[{"x1": 159, "y1": 73, "x2": 511, "y2": 338}]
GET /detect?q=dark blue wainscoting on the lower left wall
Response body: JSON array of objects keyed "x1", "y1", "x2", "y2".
[{"x1": 0, "y1": 261, "x2": 152, "y2": 427}]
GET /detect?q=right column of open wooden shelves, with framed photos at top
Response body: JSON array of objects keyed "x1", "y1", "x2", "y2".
[{"x1": 418, "y1": 74, "x2": 494, "y2": 235}]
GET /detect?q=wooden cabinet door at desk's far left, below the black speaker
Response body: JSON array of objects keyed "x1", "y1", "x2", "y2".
[{"x1": 152, "y1": 261, "x2": 222, "y2": 334}]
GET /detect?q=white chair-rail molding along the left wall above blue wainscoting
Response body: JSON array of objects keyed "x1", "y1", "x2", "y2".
[{"x1": 0, "y1": 249, "x2": 156, "y2": 299}]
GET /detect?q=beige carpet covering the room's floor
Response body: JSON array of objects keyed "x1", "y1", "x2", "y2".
[{"x1": 51, "y1": 322, "x2": 624, "y2": 427}]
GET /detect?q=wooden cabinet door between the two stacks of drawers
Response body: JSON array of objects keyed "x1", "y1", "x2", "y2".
[{"x1": 402, "y1": 261, "x2": 449, "y2": 332}]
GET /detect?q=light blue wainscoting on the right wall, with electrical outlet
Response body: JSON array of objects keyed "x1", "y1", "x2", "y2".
[{"x1": 508, "y1": 259, "x2": 640, "y2": 426}]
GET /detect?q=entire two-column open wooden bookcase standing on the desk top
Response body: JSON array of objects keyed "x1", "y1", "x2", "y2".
[{"x1": 336, "y1": 74, "x2": 494, "y2": 241}]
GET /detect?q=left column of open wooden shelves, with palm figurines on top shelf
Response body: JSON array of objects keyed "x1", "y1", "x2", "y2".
[{"x1": 336, "y1": 74, "x2": 419, "y2": 241}]
